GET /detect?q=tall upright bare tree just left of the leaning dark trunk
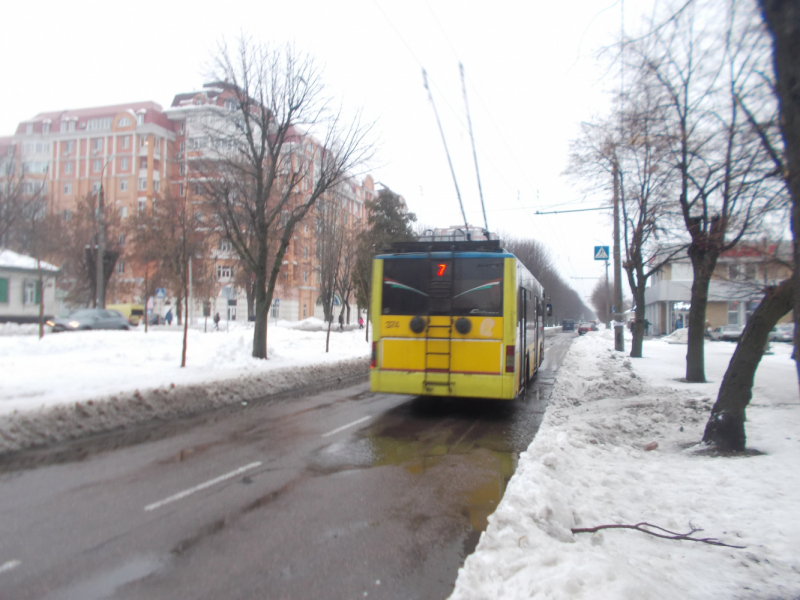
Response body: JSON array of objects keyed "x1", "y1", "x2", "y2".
[{"x1": 629, "y1": 0, "x2": 784, "y2": 382}]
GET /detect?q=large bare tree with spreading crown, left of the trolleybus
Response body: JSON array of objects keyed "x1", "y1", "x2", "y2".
[{"x1": 198, "y1": 37, "x2": 373, "y2": 359}]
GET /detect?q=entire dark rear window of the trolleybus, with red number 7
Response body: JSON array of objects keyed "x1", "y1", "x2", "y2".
[{"x1": 382, "y1": 256, "x2": 503, "y2": 316}]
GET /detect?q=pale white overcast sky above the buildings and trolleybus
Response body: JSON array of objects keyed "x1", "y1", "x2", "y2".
[{"x1": 0, "y1": 0, "x2": 651, "y2": 304}]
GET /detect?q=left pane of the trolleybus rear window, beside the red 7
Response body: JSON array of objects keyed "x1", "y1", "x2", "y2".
[{"x1": 381, "y1": 259, "x2": 428, "y2": 315}]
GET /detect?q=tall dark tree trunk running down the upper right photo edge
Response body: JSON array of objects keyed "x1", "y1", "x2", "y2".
[{"x1": 761, "y1": 0, "x2": 800, "y2": 394}]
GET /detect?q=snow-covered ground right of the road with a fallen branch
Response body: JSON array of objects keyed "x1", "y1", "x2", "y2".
[{"x1": 451, "y1": 332, "x2": 800, "y2": 600}]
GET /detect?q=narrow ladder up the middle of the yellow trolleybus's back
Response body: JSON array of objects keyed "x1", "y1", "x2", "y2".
[{"x1": 423, "y1": 252, "x2": 455, "y2": 391}]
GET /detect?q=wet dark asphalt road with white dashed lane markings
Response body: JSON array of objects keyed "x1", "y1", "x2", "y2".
[{"x1": 0, "y1": 334, "x2": 574, "y2": 600}]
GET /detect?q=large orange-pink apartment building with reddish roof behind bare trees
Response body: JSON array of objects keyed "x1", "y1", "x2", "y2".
[{"x1": 0, "y1": 84, "x2": 375, "y2": 321}]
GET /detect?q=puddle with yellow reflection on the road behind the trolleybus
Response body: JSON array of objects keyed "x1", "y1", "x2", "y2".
[{"x1": 312, "y1": 398, "x2": 544, "y2": 557}]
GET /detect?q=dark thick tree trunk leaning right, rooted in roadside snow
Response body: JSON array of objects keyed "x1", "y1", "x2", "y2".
[{"x1": 703, "y1": 279, "x2": 794, "y2": 452}]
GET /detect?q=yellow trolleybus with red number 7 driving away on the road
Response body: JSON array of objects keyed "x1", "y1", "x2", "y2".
[{"x1": 370, "y1": 240, "x2": 546, "y2": 400}]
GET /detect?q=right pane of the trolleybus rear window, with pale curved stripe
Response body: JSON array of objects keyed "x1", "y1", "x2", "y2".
[{"x1": 453, "y1": 258, "x2": 503, "y2": 316}]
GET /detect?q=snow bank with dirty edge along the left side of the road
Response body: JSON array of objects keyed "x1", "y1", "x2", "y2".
[{"x1": 0, "y1": 325, "x2": 371, "y2": 452}]
